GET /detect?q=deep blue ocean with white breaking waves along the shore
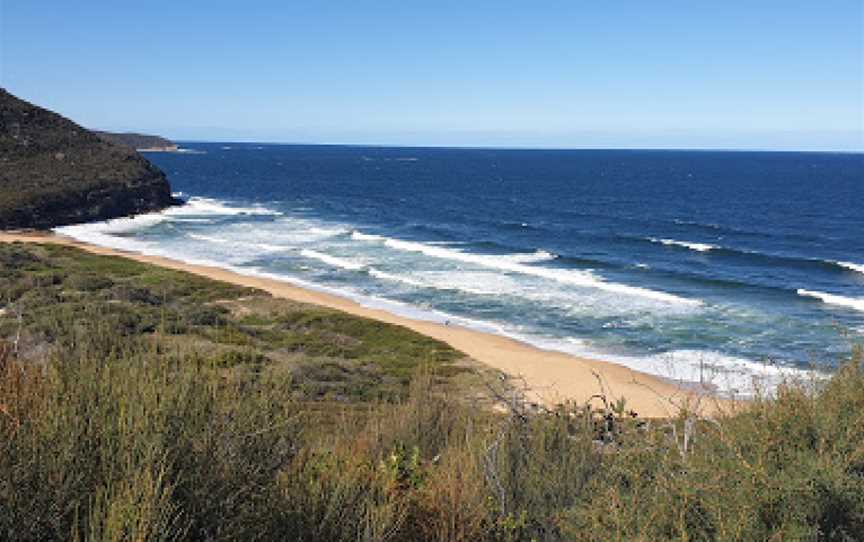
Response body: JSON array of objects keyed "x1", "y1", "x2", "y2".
[{"x1": 55, "y1": 143, "x2": 864, "y2": 393}]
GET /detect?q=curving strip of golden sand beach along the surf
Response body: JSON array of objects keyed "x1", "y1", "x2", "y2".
[{"x1": 0, "y1": 232, "x2": 732, "y2": 417}]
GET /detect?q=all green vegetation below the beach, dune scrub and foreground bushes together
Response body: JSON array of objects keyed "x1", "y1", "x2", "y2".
[{"x1": 0, "y1": 244, "x2": 864, "y2": 541}]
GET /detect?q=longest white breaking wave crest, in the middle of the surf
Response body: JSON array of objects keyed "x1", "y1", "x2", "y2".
[{"x1": 352, "y1": 238, "x2": 701, "y2": 305}]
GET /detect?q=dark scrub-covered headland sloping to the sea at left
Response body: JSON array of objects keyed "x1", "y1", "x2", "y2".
[{"x1": 0, "y1": 88, "x2": 176, "y2": 229}]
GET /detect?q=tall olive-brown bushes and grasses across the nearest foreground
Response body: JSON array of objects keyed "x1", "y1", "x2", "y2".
[{"x1": 0, "y1": 343, "x2": 864, "y2": 540}]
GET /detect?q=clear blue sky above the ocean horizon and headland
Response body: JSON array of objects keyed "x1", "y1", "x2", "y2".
[{"x1": 0, "y1": 0, "x2": 864, "y2": 150}]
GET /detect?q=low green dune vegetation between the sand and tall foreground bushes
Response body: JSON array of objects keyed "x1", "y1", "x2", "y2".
[{"x1": 0, "y1": 244, "x2": 467, "y2": 400}]
